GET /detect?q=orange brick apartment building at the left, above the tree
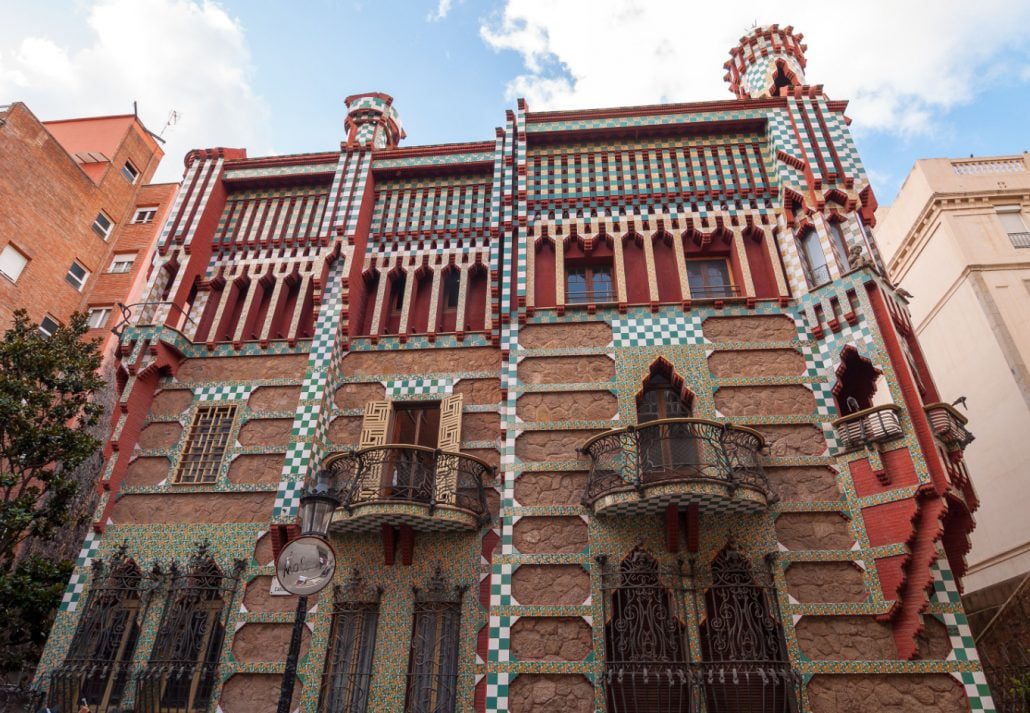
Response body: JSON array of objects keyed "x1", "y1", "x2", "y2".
[{"x1": 0, "y1": 103, "x2": 176, "y2": 357}]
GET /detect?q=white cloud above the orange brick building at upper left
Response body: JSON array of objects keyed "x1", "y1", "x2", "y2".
[{"x1": 0, "y1": 0, "x2": 271, "y2": 180}]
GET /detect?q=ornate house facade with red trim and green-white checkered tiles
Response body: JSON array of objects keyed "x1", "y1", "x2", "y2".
[{"x1": 37, "y1": 26, "x2": 995, "y2": 713}]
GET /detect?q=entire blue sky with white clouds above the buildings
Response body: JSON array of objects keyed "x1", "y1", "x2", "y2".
[{"x1": 0, "y1": 0, "x2": 1030, "y2": 203}]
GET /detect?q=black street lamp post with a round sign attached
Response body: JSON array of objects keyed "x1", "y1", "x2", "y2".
[{"x1": 275, "y1": 470, "x2": 340, "y2": 713}]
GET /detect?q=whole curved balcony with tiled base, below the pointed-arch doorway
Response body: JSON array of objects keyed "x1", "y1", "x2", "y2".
[{"x1": 580, "y1": 418, "x2": 776, "y2": 514}]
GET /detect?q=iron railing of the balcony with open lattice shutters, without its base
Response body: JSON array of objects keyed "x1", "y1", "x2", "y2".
[{"x1": 333, "y1": 444, "x2": 493, "y2": 522}]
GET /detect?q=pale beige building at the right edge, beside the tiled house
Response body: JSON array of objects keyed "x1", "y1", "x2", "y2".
[{"x1": 877, "y1": 154, "x2": 1030, "y2": 666}]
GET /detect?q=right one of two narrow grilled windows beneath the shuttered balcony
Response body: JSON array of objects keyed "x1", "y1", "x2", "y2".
[{"x1": 404, "y1": 566, "x2": 464, "y2": 713}]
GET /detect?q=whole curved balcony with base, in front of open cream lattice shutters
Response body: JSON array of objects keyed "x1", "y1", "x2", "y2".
[{"x1": 331, "y1": 444, "x2": 493, "y2": 532}]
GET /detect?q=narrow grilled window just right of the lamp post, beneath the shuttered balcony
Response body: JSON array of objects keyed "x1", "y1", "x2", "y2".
[{"x1": 318, "y1": 569, "x2": 381, "y2": 713}]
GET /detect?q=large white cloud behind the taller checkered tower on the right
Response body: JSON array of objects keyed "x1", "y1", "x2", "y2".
[{"x1": 480, "y1": 0, "x2": 1030, "y2": 134}]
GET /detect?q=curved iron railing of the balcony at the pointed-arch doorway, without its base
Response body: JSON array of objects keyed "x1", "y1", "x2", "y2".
[{"x1": 581, "y1": 418, "x2": 771, "y2": 505}]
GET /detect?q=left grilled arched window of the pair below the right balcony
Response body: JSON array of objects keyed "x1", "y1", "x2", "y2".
[{"x1": 602, "y1": 548, "x2": 691, "y2": 713}]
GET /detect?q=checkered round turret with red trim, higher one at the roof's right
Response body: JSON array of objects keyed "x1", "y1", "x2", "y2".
[{"x1": 723, "y1": 25, "x2": 808, "y2": 99}]
